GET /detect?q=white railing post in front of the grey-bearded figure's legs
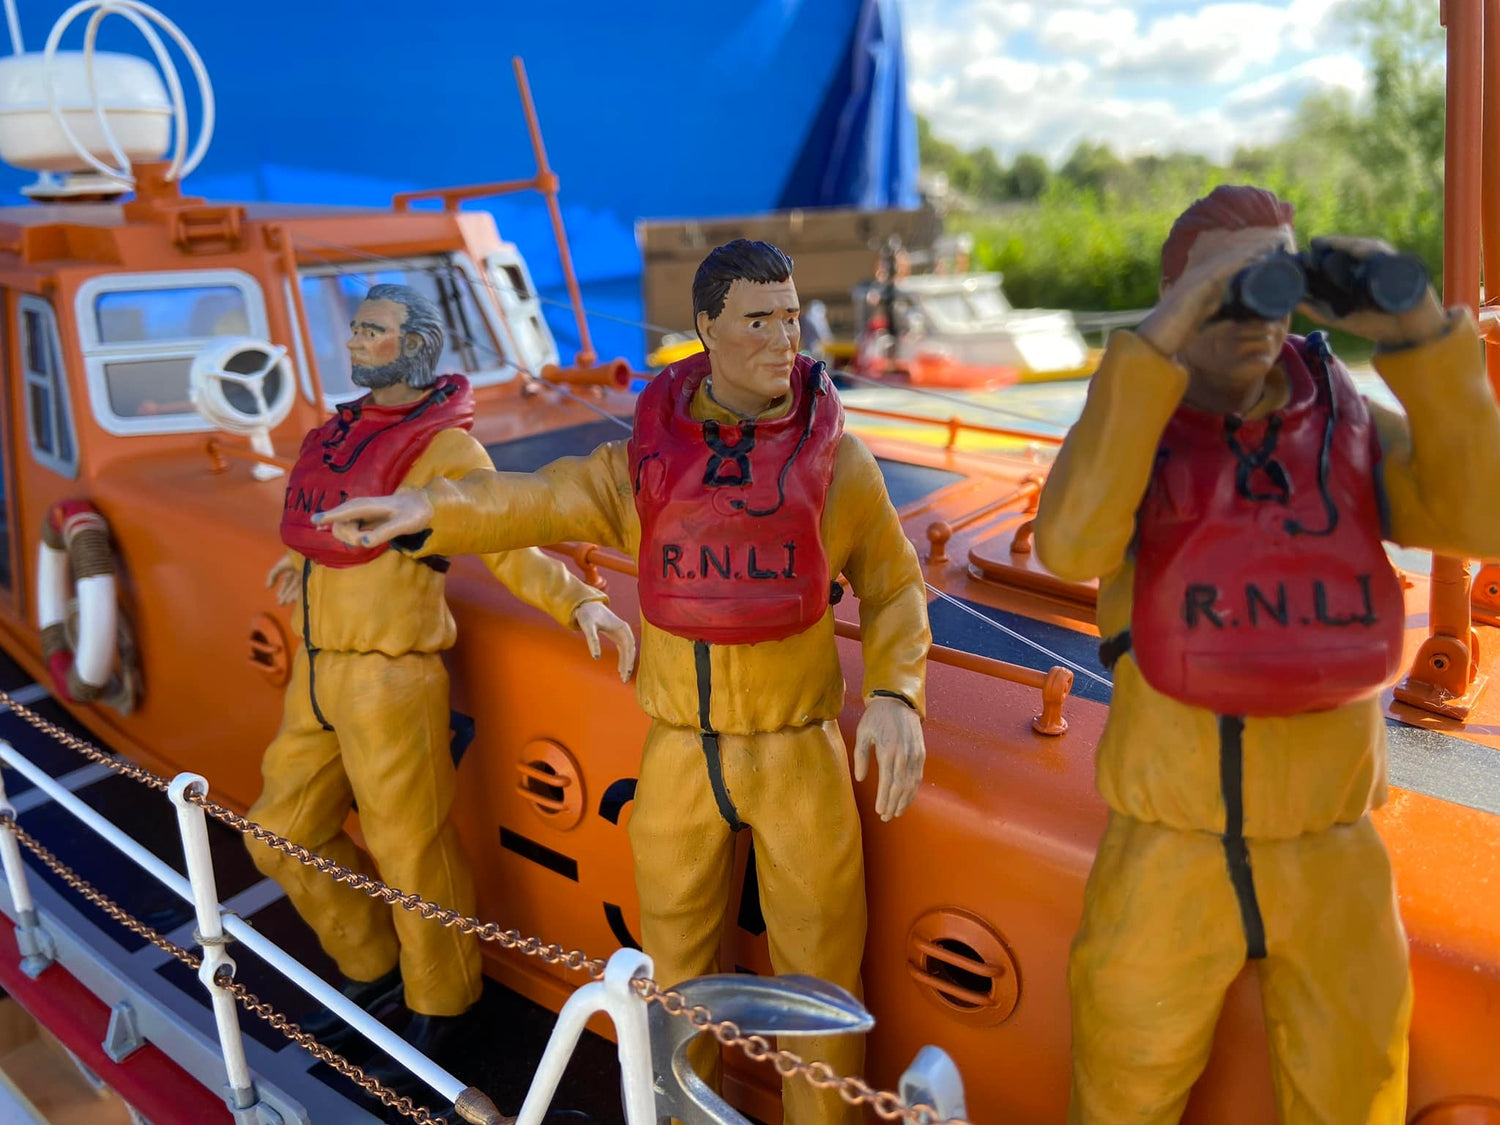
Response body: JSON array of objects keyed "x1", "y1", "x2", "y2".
[{"x1": 167, "y1": 774, "x2": 260, "y2": 1122}]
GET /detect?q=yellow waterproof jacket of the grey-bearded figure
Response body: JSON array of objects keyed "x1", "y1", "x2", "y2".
[{"x1": 288, "y1": 429, "x2": 608, "y2": 657}]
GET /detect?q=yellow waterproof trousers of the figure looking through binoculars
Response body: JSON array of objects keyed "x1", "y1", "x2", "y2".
[{"x1": 1068, "y1": 813, "x2": 1412, "y2": 1125}]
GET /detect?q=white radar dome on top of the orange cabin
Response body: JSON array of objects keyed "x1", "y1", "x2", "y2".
[{"x1": 0, "y1": 51, "x2": 173, "y2": 176}]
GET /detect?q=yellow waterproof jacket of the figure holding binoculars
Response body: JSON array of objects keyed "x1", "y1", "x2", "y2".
[{"x1": 1035, "y1": 312, "x2": 1500, "y2": 837}]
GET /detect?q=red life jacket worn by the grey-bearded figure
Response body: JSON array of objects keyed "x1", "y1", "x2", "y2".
[{"x1": 282, "y1": 375, "x2": 474, "y2": 569}]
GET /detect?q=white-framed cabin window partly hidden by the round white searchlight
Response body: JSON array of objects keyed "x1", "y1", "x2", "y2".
[{"x1": 77, "y1": 270, "x2": 270, "y2": 434}]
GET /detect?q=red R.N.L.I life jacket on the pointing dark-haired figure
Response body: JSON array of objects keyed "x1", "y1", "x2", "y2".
[{"x1": 629, "y1": 353, "x2": 843, "y2": 645}]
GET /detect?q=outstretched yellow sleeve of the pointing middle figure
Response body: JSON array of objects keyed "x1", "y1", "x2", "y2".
[{"x1": 402, "y1": 441, "x2": 635, "y2": 557}]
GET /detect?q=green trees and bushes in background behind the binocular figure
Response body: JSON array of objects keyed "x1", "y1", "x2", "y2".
[{"x1": 924, "y1": 0, "x2": 1445, "y2": 319}]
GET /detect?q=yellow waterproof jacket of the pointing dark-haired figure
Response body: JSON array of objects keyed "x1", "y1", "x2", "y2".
[{"x1": 419, "y1": 389, "x2": 932, "y2": 735}]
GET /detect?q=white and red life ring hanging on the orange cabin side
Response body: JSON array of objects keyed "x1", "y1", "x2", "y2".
[{"x1": 36, "y1": 500, "x2": 141, "y2": 714}]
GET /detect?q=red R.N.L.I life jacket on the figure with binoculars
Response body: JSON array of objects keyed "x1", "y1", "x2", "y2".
[{"x1": 1130, "y1": 336, "x2": 1406, "y2": 716}]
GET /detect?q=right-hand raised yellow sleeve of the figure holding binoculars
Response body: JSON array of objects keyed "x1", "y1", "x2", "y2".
[{"x1": 1371, "y1": 309, "x2": 1500, "y2": 560}]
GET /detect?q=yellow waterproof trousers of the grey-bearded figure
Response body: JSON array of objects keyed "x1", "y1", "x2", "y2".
[{"x1": 249, "y1": 648, "x2": 482, "y2": 1016}]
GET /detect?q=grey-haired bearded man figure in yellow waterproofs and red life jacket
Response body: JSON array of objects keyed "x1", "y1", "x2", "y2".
[{"x1": 258, "y1": 285, "x2": 635, "y2": 1083}]
